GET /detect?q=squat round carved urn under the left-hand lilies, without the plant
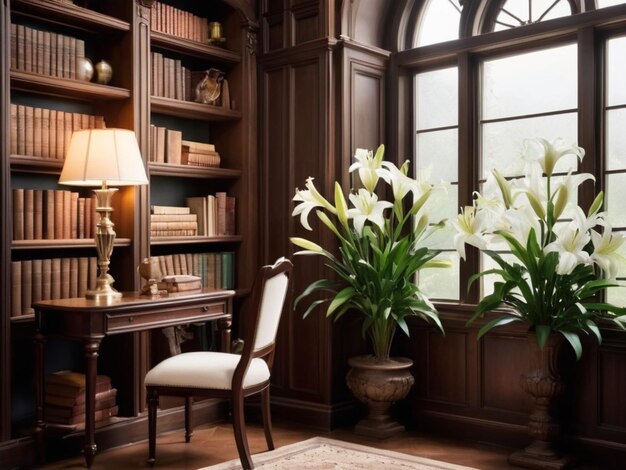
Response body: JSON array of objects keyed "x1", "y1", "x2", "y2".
[{"x1": 346, "y1": 356, "x2": 415, "y2": 439}]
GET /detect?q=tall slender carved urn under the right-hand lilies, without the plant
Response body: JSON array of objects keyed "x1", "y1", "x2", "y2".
[{"x1": 509, "y1": 332, "x2": 572, "y2": 469}]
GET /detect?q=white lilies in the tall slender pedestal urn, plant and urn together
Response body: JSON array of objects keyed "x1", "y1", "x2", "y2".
[{"x1": 453, "y1": 139, "x2": 626, "y2": 468}]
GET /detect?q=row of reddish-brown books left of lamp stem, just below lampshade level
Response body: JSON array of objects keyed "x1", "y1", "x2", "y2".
[{"x1": 12, "y1": 188, "x2": 98, "y2": 240}]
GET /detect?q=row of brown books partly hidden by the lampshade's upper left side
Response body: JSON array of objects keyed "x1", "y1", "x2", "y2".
[{"x1": 10, "y1": 103, "x2": 106, "y2": 160}]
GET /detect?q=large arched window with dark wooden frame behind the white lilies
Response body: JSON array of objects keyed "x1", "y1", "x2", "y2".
[{"x1": 402, "y1": 0, "x2": 626, "y2": 306}]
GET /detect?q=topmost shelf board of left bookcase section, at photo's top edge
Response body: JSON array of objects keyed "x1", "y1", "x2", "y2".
[{"x1": 11, "y1": 0, "x2": 130, "y2": 33}]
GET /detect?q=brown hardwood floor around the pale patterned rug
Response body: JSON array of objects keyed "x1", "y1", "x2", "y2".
[{"x1": 38, "y1": 423, "x2": 515, "y2": 470}]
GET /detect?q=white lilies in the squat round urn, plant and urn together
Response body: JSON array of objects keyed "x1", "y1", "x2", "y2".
[{"x1": 291, "y1": 145, "x2": 450, "y2": 438}]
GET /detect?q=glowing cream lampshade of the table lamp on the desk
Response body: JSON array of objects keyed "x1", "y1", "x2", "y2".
[{"x1": 59, "y1": 129, "x2": 148, "y2": 186}]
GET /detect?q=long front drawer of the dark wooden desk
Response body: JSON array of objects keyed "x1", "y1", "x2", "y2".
[{"x1": 107, "y1": 302, "x2": 230, "y2": 334}]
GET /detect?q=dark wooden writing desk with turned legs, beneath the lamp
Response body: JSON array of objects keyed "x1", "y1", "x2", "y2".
[{"x1": 33, "y1": 289, "x2": 234, "y2": 467}]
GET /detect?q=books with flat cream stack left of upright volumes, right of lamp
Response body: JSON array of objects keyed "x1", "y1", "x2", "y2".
[{"x1": 150, "y1": 191, "x2": 236, "y2": 237}]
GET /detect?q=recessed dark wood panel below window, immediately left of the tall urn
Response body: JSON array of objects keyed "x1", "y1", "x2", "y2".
[{"x1": 480, "y1": 334, "x2": 531, "y2": 413}]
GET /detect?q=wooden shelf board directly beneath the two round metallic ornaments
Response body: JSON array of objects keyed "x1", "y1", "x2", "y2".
[{"x1": 11, "y1": 70, "x2": 130, "y2": 101}]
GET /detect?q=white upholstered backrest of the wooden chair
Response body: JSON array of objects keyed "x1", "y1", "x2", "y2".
[{"x1": 244, "y1": 258, "x2": 293, "y2": 356}]
